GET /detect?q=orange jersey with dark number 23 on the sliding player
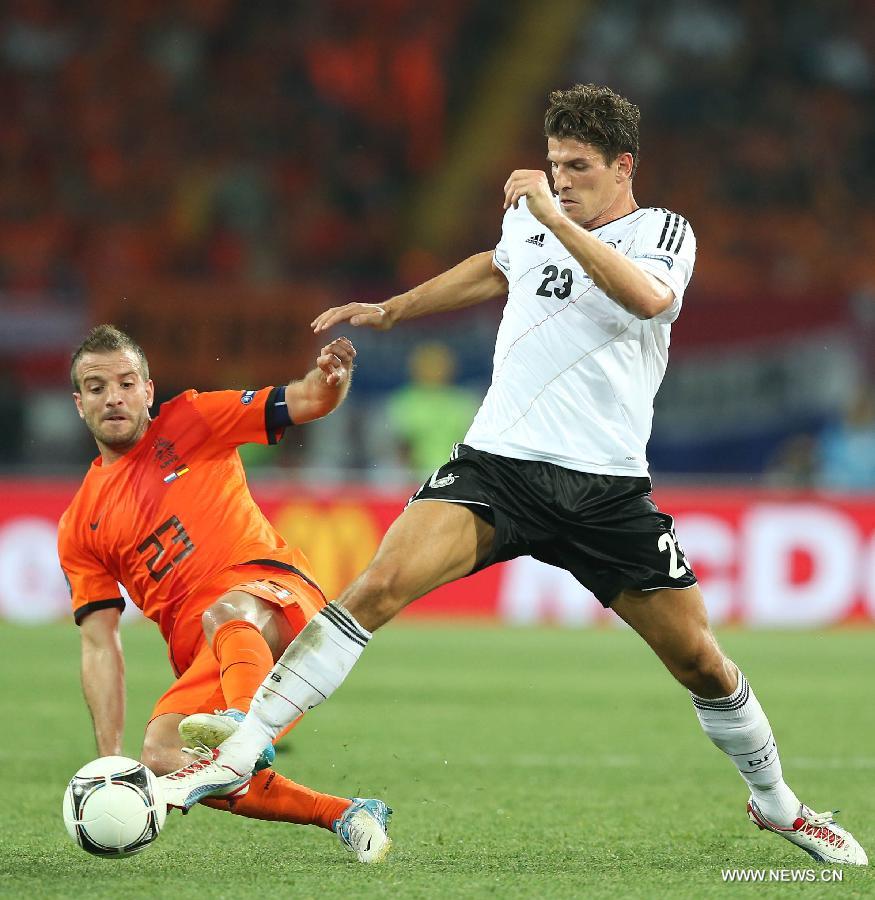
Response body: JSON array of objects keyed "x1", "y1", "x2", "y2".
[{"x1": 58, "y1": 388, "x2": 309, "y2": 642}]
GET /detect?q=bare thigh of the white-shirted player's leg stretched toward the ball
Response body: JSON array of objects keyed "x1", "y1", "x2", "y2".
[{"x1": 340, "y1": 500, "x2": 495, "y2": 630}]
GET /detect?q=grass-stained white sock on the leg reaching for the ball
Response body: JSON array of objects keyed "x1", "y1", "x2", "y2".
[{"x1": 221, "y1": 603, "x2": 371, "y2": 772}]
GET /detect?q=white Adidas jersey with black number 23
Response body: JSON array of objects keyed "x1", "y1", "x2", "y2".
[{"x1": 465, "y1": 199, "x2": 696, "y2": 476}]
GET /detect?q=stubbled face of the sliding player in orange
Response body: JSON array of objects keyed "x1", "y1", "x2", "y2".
[{"x1": 73, "y1": 350, "x2": 155, "y2": 454}]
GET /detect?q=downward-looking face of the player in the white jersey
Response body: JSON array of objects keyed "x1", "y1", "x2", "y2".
[{"x1": 547, "y1": 137, "x2": 632, "y2": 227}]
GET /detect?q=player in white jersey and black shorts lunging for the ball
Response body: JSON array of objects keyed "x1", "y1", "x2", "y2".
[{"x1": 171, "y1": 85, "x2": 867, "y2": 865}]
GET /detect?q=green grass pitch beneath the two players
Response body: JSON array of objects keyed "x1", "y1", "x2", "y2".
[{"x1": 0, "y1": 622, "x2": 875, "y2": 900}]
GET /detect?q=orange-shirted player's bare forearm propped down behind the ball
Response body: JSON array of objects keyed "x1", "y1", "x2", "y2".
[{"x1": 80, "y1": 609, "x2": 125, "y2": 756}]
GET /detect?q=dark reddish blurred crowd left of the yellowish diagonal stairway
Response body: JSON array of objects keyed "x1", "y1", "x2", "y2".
[{"x1": 0, "y1": 0, "x2": 495, "y2": 291}]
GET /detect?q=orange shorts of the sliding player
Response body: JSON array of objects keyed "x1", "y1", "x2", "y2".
[{"x1": 149, "y1": 566, "x2": 326, "y2": 721}]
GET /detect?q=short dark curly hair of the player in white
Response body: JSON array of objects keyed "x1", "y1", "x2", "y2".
[{"x1": 544, "y1": 84, "x2": 641, "y2": 175}]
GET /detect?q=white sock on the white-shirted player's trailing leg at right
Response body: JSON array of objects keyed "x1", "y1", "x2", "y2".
[{"x1": 690, "y1": 671, "x2": 800, "y2": 827}]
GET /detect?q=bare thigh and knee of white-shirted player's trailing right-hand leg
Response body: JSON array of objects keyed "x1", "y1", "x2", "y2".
[{"x1": 610, "y1": 584, "x2": 737, "y2": 697}]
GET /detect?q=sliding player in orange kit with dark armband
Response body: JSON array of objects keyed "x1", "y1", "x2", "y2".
[{"x1": 58, "y1": 325, "x2": 391, "y2": 862}]
